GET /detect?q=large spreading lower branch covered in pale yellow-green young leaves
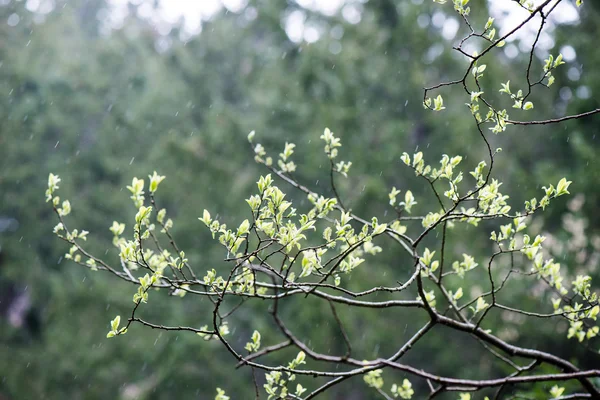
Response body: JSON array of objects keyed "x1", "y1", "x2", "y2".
[{"x1": 47, "y1": 119, "x2": 600, "y2": 399}]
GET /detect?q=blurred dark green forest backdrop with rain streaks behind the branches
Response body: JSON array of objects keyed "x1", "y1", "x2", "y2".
[{"x1": 0, "y1": 0, "x2": 600, "y2": 400}]
